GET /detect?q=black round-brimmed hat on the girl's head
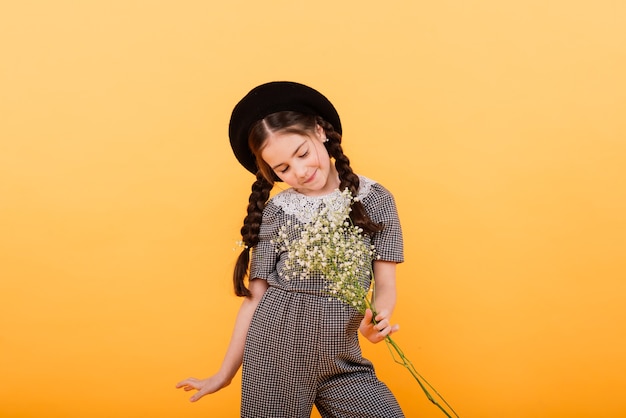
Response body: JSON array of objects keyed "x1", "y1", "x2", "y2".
[{"x1": 228, "y1": 81, "x2": 341, "y2": 174}]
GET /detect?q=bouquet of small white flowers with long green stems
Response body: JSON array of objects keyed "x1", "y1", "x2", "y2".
[{"x1": 274, "y1": 189, "x2": 458, "y2": 418}]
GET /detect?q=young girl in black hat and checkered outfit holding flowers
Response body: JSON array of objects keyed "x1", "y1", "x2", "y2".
[{"x1": 177, "y1": 82, "x2": 404, "y2": 418}]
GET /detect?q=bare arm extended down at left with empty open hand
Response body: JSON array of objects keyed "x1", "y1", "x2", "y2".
[{"x1": 176, "y1": 279, "x2": 268, "y2": 402}]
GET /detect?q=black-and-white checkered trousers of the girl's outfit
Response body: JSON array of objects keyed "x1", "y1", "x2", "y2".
[{"x1": 236, "y1": 287, "x2": 404, "y2": 418}]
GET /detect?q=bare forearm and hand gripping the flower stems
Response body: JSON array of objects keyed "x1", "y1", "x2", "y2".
[{"x1": 359, "y1": 260, "x2": 400, "y2": 343}]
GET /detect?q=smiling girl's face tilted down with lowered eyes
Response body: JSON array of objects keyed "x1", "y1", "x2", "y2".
[{"x1": 261, "y1": 126, "x2": 339, "y2": 196}]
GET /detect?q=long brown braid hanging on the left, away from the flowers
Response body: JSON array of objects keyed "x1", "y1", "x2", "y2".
[{"x1": 233, "y1": 172, "x2": 274, "y2": 296}]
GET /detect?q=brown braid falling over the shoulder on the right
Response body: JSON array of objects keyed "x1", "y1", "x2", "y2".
[{"x1": 317, "y1": 117, "x2": 383, "y2": 235}]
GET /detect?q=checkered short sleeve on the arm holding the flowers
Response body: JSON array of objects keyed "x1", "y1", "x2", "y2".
[{"x1": 362, "y1": 183, "x2": 404, "y2": 263}]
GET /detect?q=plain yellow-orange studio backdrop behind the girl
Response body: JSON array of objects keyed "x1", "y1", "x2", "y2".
[{"x1": 0, "y1": 0, "x2": 626, "y2": 418}]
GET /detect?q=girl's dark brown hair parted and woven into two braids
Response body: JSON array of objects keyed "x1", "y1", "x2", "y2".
[{"x1": 233, "y1": 111, "x2": 383, "y2": 296}]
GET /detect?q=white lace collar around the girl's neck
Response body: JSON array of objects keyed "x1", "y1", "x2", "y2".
[{"x1": 272, "y1": 176, "x2": 376, "y2": 223}]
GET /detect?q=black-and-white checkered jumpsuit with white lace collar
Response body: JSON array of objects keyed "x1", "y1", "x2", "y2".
[{"x1": 241, "y1": 177, "x2": 404, "y2": 418}]
